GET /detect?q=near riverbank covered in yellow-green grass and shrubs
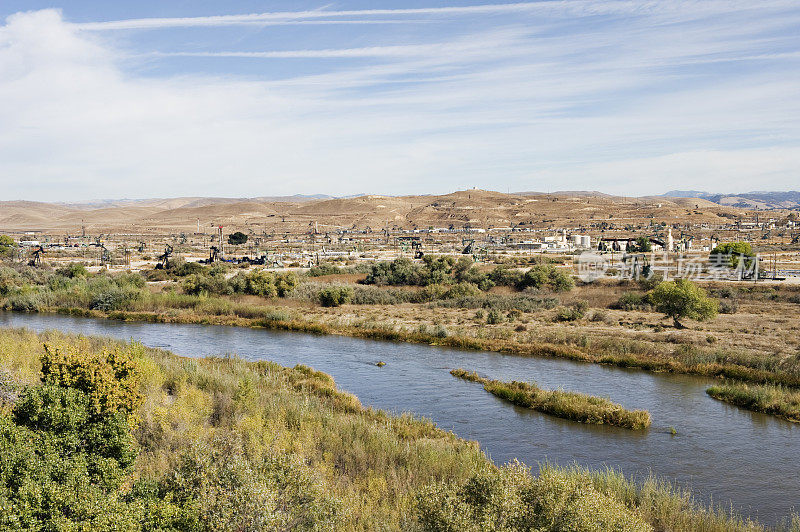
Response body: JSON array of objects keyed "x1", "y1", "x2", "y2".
[{"x1": 0, "y1": 329, "x2": 800, "y2": 532}]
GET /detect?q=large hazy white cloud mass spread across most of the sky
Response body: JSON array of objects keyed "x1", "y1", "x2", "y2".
[{"x1": 0, "y1": 6, "x2": 800, "y2": 200}]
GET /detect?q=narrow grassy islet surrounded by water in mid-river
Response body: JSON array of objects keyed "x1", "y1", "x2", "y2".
[{"x1": 450, "y1": 369, "x2": 650, "y2": 430}]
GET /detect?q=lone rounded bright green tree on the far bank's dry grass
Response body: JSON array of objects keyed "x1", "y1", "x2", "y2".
[{"x1": 648, "y1": 279, "x2": 719, "y2": 329}]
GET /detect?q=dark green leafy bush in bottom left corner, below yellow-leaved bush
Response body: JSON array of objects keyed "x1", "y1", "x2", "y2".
[{"x1": 0, "y1": 386, "x2": 139, "y2": 530}]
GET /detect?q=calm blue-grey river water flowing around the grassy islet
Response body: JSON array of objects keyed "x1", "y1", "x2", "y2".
[{"x1": 0, "y1": 312, "x2": 800, "y2": 523}]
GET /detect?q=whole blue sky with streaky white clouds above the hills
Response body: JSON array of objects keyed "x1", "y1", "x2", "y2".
[{"x1": 0, "y1": 0, "x2": 800, "y2": 201}]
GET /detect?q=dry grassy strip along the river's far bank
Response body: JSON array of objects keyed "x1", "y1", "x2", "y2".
[{"x1": 40, "y1": 298, "x2": 800, "y2": 387}]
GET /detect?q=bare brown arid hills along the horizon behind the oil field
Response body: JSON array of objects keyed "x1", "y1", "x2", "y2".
[{"x1": 0, "y1": 190, "x2": 788, "y2": 234}]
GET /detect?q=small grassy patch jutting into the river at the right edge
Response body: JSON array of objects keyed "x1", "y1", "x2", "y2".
[{"x1": 706, "y1": 383, "x2": 800, "y2": 423}]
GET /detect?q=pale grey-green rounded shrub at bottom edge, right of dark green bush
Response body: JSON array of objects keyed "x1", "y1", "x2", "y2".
[{"x1": 139, "y1": 437, "x2": 341, "y2": 532}]
